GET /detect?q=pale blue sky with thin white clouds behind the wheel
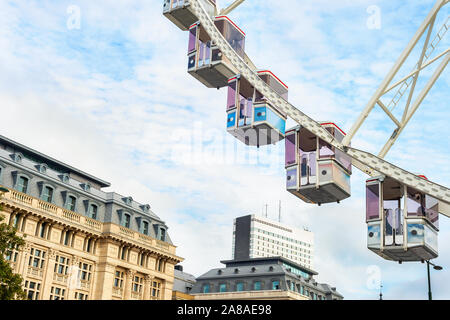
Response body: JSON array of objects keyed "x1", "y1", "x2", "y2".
[{"x1": 0, "y1": 0, "x2": 450, "y2": 299}]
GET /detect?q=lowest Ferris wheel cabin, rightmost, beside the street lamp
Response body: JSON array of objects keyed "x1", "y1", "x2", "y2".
[{"x1": 366, "y1": 176, "x2": 439, "y2": 262}]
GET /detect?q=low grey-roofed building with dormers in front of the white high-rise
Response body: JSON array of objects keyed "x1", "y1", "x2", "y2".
[{"x1": 191, "y1": 257, "x2": 343, "y2": 300}]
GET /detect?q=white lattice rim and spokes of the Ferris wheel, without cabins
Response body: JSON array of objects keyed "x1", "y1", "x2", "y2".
[{"x1": 184, "y1": 0, "x2": 450, "y2": 217}]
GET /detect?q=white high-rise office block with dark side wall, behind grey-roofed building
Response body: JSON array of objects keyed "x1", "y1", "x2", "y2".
[{"x1": 232, "y1": 215, "x2": 314, "y2": 269}]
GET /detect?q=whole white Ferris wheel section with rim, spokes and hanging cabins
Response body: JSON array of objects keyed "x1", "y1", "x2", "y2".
[{"x1": 163, "y1": 0, "x2": 450, "y2": 263}]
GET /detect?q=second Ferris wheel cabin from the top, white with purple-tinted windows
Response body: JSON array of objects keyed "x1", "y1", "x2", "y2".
[{"x1": 188, "y1": 16, "x2": 245, "y2": 88}]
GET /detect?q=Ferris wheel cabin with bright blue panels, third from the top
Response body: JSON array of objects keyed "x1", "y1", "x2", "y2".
[{"x1": 227, "y1": 70, "x2": 288, "y2": 147}]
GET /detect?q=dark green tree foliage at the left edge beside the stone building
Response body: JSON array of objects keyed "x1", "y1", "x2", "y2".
[{"x1": 0, "y1": 201, "x2": 26, "y2": 300}]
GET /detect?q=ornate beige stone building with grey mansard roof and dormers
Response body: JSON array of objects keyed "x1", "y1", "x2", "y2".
[{"x1": 0, "y1": 136, "x2": 183, "y2": 300}]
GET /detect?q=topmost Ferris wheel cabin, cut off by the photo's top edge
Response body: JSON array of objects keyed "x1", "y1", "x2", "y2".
[{"x1": 163, "y1": 0, "x2": 217, "y2": 31}]
